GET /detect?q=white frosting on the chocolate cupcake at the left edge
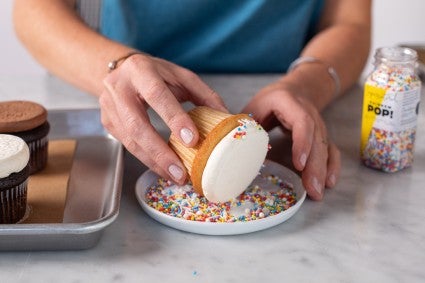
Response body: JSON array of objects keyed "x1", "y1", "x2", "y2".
[{"x1": 0, "y1": 134, "x2": 30, "y2": 178}]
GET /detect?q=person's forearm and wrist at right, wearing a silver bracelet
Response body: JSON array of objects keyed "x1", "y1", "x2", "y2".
[{"x1": 283, "y1": 1, "x2": 370, "y2": 110}]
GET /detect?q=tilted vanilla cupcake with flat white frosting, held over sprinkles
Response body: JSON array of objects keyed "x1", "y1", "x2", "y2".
[{"x1": 169, "y1": 106, "x2": 269, "y2": 202}]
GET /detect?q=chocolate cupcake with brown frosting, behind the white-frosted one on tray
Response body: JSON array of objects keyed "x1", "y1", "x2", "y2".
[{"x1": 0, "y1": 101, "x2": 50, "y2": 174}]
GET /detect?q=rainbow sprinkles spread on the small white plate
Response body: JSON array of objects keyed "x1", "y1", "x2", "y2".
[{"x1": 145, "y1": 175, "x2": 297, "y2": 223}]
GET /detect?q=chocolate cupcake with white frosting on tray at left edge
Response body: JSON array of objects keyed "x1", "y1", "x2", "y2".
[{"x1": 0, "y1": 134, "x2": 30, "y2": 224}]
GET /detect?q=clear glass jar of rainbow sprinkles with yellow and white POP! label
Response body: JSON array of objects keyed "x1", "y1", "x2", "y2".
[{"x1": 360, "y1": 47, "x2": 421, "y2": 172}]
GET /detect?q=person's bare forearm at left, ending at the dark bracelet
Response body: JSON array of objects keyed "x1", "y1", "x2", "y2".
[{"x1": 14, "y1": 0, "x2": 130, "y2": 95}]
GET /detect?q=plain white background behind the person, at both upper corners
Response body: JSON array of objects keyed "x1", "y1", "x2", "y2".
[{"x1": 0, "y1": 0, "x2": 425, "y2": 76}]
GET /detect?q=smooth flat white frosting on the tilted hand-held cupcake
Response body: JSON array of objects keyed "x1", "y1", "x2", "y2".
[{"x1": 202, "y1": 120, "x2": 269, "y2": 202}]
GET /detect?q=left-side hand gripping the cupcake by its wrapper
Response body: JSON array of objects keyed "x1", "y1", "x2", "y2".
[{"x1": 99, "y1": 54, "x2": 226, "y2": 184}]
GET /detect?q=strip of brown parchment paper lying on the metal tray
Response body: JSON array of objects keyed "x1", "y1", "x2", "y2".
[{"x1": 23, "y1": 140, "x2": 77, "y2": 223}]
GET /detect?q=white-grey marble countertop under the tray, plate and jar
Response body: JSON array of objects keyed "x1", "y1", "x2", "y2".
[{"x1": 0, "y1": 75, "x2": 425, "y2": 283}]
